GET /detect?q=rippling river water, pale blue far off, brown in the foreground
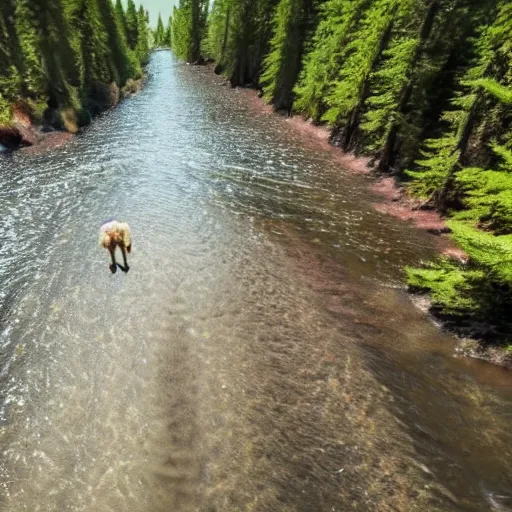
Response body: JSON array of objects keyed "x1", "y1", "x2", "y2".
[{"x1": 0, "y1": 52, "x2": 512, "y2": 512}]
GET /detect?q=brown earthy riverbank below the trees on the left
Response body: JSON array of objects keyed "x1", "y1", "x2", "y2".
[{"x1": 0, "y1": 75, "x2": 147, "y2": 154}]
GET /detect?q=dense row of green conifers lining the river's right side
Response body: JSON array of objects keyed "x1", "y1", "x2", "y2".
[{"x1": 172, "y1": 0, "x2": 512, "y2": 342}]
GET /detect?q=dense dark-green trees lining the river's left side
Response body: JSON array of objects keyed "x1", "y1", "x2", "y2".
[{"x1": 0, "y1": 0, "x2": 150, "y2": 135}]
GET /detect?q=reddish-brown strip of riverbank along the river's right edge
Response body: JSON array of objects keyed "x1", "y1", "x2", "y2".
[{"x1": 234, "y1": 83, "x2": 512, "y2": 370}]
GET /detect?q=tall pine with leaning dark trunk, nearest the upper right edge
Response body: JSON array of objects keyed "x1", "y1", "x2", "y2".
[{"x1": 406, "y1": 1, "x2": 506, "y2": 202}]
